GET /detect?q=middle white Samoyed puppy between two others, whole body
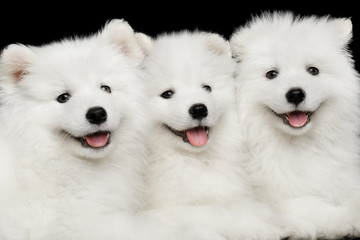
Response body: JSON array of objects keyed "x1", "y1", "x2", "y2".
[{"x1": 138, "y1": 30, "x2": 310, "y2": 239}]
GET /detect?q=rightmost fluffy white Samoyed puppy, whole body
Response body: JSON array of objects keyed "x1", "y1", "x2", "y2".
[{"x1": 230, "y1": 12, "x2": 360, "y2": 239}]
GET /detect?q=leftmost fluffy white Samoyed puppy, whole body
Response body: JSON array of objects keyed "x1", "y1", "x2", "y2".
[{"x1": 0, "y1": 19, "x2": 191, "y2": 240}]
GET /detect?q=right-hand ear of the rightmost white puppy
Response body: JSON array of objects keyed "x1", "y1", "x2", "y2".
[{"x1": 329, "y1": 18, "x2": 353, "y2": 46}]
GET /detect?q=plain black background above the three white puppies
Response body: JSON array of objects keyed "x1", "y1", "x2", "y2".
[{"x1": 0, "y1": 0, "x2": 360, "y2": 70}]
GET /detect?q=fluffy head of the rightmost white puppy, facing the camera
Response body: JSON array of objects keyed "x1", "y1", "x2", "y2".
[{"x1": 231, "y1": 14, "x2": 354, "y2": 135}]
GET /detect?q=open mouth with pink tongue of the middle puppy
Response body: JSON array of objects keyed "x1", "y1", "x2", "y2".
[{"x1": 164, "y1": 124, "x2": 209, "y2": 147}]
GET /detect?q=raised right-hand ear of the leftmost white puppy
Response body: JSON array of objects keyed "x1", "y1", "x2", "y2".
[{"x1": 99, "y1": 19, "x2": 144, "y2": 61}]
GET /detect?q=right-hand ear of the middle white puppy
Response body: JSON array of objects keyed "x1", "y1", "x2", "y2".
[{"x1": 205, "y1": 33, "x2": 231, "y2": 57}]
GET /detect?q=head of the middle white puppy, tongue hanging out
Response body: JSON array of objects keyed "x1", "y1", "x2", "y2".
[{"x1": 144, "y1": 32, "x2": 234, "y2": 151}]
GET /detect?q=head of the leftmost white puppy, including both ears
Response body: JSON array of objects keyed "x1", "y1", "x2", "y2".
[{"x1": 2, "y1": 21, "x2": 144, "y2": 158}]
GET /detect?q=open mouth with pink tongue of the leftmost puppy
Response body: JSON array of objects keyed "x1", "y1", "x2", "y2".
[{"x1": 63, "y1": 131, "x2": 111, "y2": 149}]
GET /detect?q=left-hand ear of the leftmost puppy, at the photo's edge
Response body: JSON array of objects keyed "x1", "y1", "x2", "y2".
[{"x1": 0, "y1": 44, "x2": 36, "y2": 83}]
